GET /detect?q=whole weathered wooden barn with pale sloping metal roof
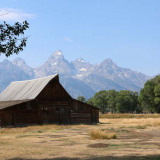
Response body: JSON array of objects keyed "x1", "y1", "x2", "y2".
[{"x1": 0, "y1": 75, "x2": 99, "y2": 127}]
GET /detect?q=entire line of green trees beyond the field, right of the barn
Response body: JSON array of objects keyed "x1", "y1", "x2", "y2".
[{"x1": 77, "y1": 75, "x2": 160, "y2": 113}]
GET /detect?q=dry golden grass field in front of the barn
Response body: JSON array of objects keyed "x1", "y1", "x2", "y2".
[{"x1": 0, "y1": 115, "x2": 160, "y2": 160}]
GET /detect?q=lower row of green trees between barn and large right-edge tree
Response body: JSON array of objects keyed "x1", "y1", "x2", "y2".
[{"x1": 87, "y1": 90, "x2": 138, "y2": 113}]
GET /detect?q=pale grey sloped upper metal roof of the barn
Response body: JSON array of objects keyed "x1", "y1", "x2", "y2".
[{"x1": 0, "y1": 74, "x2": 58, "y2": 101}]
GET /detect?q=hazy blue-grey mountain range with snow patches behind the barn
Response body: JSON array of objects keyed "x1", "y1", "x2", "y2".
[{"x1": 0, "y1": 51, "x2": 150, "y2": 98}]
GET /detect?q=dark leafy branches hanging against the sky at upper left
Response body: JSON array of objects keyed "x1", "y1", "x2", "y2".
[{"x1": 0, "y1": 21, "x2": 29, "y2": 57}]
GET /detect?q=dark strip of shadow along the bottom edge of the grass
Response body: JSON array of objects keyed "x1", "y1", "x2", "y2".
[{"x1": 8, "y1": 155, "x2": 160, "y2": 160}]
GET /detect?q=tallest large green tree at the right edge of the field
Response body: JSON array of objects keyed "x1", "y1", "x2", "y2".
[{"x1": 139, "y1": 75, "x2": 160, "y2": 113}]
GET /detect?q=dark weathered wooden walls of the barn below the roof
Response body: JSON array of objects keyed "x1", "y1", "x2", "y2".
[{"x1": 0, "y1": 79, "x2": 99, "y2": 126}]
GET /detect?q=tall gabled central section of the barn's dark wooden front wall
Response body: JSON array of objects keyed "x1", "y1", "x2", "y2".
[{"x1": 37, "y1": 81, "x2": 71, "y2": 124}]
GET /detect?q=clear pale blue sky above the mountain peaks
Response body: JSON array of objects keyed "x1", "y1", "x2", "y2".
[{"x1": 0, "y1": 0, "x2": 160, "y2": 76}]
